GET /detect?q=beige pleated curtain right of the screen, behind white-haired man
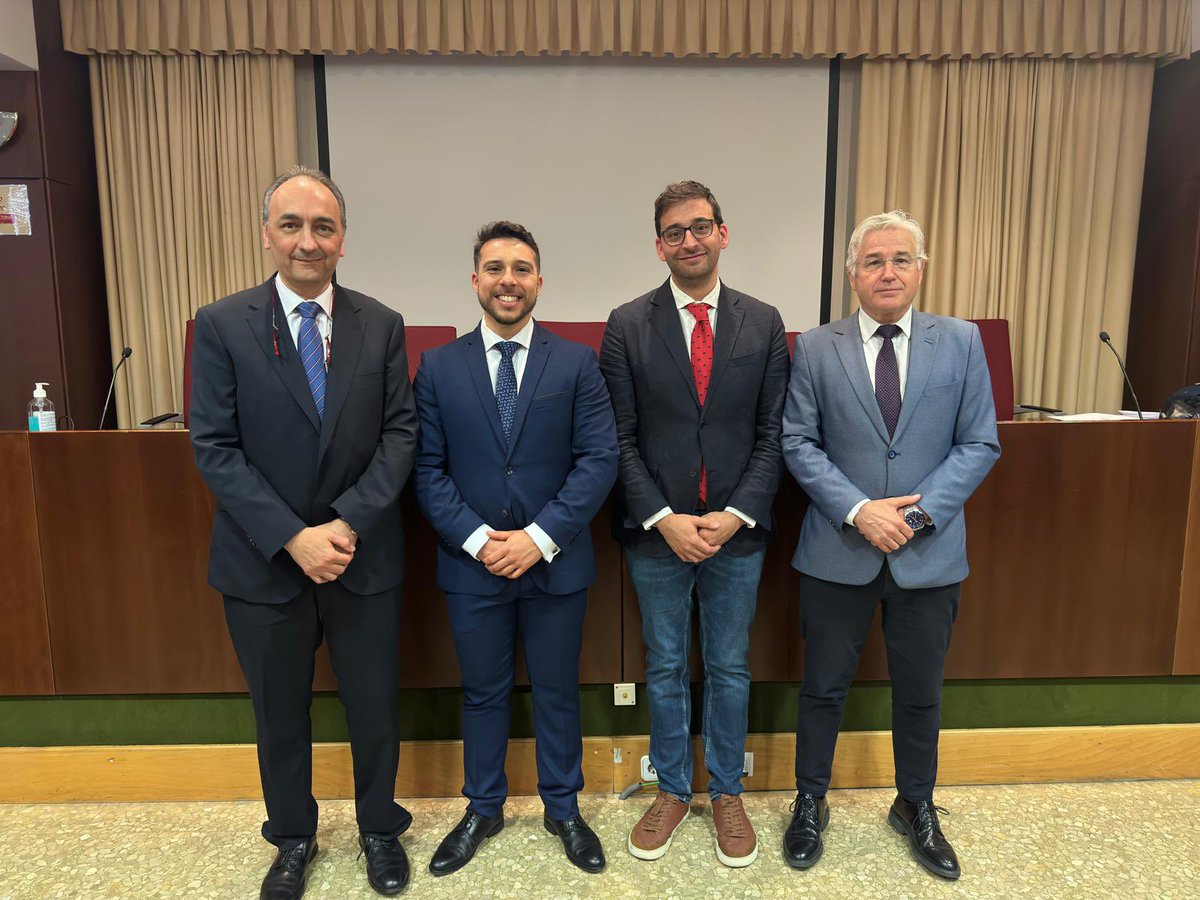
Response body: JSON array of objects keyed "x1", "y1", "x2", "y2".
[{"x1": 854, "y1": 60, "x2": 1154, "y2": 412}]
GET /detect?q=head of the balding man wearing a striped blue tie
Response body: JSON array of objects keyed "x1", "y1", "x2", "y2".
[{"x1": 263, "y1": 175, "x2": 346, "y2": 300}]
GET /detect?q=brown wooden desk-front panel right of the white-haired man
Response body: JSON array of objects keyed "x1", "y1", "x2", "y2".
[{"x1": 947, "y1": 421, "x2": 1196, "y2": 678}]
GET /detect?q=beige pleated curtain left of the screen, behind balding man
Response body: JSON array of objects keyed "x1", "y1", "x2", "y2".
[{"x1": 90, "y1": 54, "x2": 296, "y2": 428}]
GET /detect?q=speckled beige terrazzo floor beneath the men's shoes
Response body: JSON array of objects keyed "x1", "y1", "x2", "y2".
[{"x1": 0, "y1": 781, "x2": 1200, "y2": 900}]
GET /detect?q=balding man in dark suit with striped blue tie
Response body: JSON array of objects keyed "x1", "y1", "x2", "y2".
[{"x1": 191, "y1": 167, "x2": 418, "y2": 900}]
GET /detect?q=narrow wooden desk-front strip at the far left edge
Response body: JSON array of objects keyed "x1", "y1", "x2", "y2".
[{"x1": 0, "y1": 433, "x2": 54, "y2": 696}]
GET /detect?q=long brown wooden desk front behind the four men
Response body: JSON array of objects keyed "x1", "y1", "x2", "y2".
[{"x1": 0, "y1": 422, "x2": 1200, "y2": 695}]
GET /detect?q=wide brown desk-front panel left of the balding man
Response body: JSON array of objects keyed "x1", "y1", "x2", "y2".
[{"x1": 32, "y1": 432, "x2": 246, "y2": 694}]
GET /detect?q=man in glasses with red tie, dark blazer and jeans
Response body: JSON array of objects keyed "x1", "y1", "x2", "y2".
[{"x1": 600, "y1": 181, "x2": 787, "y2": 866}]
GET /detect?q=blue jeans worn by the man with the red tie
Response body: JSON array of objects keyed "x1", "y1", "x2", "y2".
[{"x1": 626, "y1": 550, "x2": 764, "y2": 803}]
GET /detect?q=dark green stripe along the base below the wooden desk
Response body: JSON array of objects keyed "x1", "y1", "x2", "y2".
[{"x1": 0, "y1": 677, "x2": 1200, "y2": 746}]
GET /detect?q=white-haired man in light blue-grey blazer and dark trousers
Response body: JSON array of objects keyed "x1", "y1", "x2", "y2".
[{"x1": 782, "y1": 210, "x2": 1000, "y2": 878}]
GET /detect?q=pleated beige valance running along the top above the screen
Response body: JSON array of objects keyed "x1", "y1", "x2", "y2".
[{"x1": 60, "y1": 0, "x2": 1190, "y2": 59}]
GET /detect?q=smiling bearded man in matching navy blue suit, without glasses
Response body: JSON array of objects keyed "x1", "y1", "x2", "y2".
[{"x1": 414, "y1": 222, "x2": 617, "y2": 875}]
